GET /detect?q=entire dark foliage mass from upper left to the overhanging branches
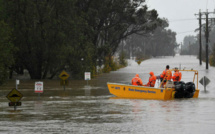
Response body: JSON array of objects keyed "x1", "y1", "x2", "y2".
[{"x1": 0, "y1": 0, "x2": 166, "y2": 79}]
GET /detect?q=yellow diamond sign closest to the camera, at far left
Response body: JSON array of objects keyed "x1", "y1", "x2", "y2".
[{"x1": 6, "y1": 88, "x2": 23, "y2": 102}]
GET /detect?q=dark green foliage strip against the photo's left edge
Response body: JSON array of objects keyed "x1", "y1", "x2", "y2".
[{"x1": 0, "y1": 21, "x2": 14, "y2": 85}]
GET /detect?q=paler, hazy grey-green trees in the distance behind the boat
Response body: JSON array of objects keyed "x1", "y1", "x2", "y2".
[{"x1": 123, "y1": 19, "x2": 177, "y2": 58}]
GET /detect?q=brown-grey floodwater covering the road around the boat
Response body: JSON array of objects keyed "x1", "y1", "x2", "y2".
[{"x1": 0, "y1": 56, "x2": 215, "y2": 134}]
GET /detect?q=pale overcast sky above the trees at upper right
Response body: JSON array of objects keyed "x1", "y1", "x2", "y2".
[{"x1": 146, "y1": 0, "x2": 215, "y2": 43}]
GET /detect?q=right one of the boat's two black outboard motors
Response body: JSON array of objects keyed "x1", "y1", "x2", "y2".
[{"x1": 184, "y1": 82, "x2": 196, "y2": 98}]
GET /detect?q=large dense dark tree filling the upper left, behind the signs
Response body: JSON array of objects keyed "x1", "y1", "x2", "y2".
[{"x1": 4, "y1": 0, "x2": 90, "y2": 79}]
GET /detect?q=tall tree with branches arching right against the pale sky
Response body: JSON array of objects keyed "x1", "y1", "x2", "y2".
[{"x1": 77, "y1": 0, "x2": 162, "y2": 71}]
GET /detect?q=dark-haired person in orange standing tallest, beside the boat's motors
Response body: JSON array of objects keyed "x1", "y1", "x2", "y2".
[{"x1": 160, "y1": 65, "x2": 172, "y2": 86}]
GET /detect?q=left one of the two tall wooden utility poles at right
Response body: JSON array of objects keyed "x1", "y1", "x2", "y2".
[{"x1": 199, "y1": 9, "x2": 202, "y2": 65}]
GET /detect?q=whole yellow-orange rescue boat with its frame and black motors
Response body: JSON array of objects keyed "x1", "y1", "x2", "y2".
[{"x1": 107, "y1": 70, "x2": 199, "y2": 100}]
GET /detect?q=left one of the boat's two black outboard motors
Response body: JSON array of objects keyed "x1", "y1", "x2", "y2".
[{"x1": 174, "y1": 81, "x2": 185, "y2": 98}]
